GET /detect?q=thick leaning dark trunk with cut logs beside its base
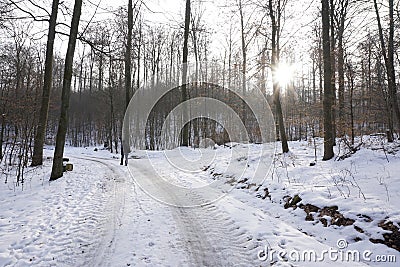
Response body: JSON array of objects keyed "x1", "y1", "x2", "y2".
[{"x1": 50, "y1": 0, "x2": 82, "y2": 180}]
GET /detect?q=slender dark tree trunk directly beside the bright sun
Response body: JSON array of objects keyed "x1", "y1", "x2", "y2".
[{"x1": 269, "y1": 0, "x2": 289, "y2": 153}]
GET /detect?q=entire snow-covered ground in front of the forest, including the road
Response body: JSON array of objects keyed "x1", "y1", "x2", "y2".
[{"x1": 0, "y1": 138, "x2": 400, "y2": 266}]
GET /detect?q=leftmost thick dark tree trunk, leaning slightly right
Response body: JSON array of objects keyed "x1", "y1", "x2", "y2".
[{"x1": 32, "y1": 0, "x2": 59, "y2": 166}]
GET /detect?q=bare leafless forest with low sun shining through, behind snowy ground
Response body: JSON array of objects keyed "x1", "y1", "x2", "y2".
[{"x1": 0, "y1": 0, "x2": 400, "y2": 184}]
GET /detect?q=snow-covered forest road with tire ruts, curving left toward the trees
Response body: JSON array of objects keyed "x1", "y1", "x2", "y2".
[{"x1": 74, "y1": 157, "x2": 256, "y2": 266}]
